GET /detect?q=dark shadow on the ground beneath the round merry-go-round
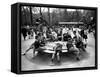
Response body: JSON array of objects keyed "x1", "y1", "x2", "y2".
[{"x1": 25, "y1": 51, "x2": 89, "y2": 66}]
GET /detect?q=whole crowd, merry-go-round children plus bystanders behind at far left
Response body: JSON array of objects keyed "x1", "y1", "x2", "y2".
[{"x1": 22, "y1": 25, "x2": 95, "y2": 63}]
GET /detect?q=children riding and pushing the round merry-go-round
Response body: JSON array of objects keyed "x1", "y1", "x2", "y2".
[{"x1": 23, "y1": 25, "x2": 87, "y2": 63}]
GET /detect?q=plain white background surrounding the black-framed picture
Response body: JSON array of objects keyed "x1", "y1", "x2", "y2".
[{"x1": 0, "y1": 0, "x2": 100, "y2": 77}]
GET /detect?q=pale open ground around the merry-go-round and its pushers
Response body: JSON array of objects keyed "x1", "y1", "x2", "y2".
[{"x1": 21, "y1": 34, "x2": 95, "y2": 71}]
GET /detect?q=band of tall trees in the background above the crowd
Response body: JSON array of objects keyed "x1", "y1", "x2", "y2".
[{"x1": 21, "y1": 6, "x2": 95, "y2": 26}]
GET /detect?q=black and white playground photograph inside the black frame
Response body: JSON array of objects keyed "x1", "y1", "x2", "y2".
[{"x1": 20, "y1": 5, "x2": 97, "y2": 71}]
